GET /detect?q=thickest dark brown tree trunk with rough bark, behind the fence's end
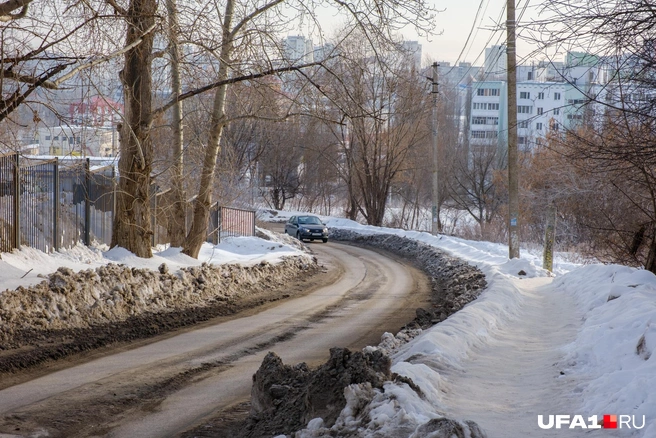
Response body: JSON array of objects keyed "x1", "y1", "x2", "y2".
[{"x1": 111, "y1": 0, "x2": 157, "y2": 257}]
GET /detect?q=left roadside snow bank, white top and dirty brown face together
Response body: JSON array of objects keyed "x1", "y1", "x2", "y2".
[{"x1": 0, "y1": 231, "x2": 315, "y2": 338}]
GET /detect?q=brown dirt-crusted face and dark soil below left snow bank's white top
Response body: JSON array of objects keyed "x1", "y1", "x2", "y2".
[{"x1": 0, "y1": 256, "x2": 326, "y2": 388}]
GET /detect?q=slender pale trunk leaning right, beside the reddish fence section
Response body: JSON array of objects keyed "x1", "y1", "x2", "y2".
[{"x1": 182, "y1": 0, "x2": 235, "y2": 258}]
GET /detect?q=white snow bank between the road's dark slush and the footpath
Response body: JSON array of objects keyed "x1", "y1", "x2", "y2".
[{"x1": 295, "y1": 229, "x2": 548, "y2": 438}]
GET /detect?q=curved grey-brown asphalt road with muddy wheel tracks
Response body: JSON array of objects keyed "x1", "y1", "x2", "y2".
[{"x1": 0, "y1": 244, "x2": 424, "y2": 438}]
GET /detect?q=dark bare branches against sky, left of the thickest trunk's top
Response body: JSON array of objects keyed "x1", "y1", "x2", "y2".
[{"x1": 0, "y1": 0, "x2": 126, "y2": 128}]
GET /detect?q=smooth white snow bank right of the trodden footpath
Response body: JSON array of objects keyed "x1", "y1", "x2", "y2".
[{"x1": 553, "y1": 265, "x2": 656, "y2": 437}]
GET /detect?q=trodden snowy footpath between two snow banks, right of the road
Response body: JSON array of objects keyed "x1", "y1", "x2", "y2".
[{"x1": 442, "y1": 277, "x2": 587, "y2": 437}]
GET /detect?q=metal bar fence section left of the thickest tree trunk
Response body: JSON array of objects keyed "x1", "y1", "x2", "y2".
[{"x1": 0, "y1": 154, "x2": 115, "y2": 252}]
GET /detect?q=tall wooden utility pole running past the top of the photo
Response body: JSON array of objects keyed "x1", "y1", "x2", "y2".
[{"x1": 506, "y1": 0, "x2": 519, "y2": 259}]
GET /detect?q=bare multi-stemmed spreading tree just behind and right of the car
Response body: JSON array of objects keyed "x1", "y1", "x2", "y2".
[{"x1": 316, "y1": 37, "x2": 428, "y2": 225}]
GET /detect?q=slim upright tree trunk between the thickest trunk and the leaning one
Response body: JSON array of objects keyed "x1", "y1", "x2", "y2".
[{"x1": 166, "y1": 0, "x2": 187, "y2": 247}]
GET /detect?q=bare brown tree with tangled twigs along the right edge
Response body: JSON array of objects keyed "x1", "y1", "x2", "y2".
[{"x1": 524, "y1": 0, "x2": 656, "y2": 271}]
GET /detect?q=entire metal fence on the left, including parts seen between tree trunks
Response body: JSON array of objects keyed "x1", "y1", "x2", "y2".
[{"x1": 0, "y1": 154, "x2": 255, "y2": 252}]
